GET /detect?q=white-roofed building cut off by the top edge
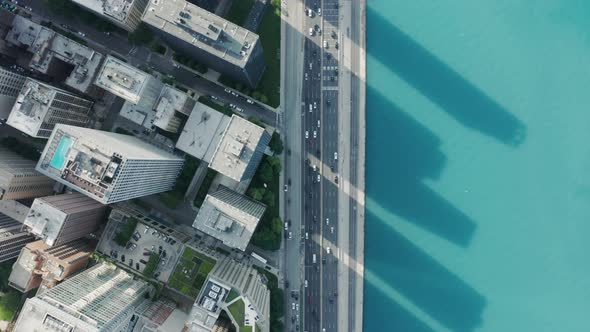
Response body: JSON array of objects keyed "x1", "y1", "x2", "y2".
[{"x1": 72, "y1": 0, "x2": 148, "y2": 31}]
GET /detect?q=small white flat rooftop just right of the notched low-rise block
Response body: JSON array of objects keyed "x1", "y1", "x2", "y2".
[{"x1": 94, "y1": 56, "x2": 153, "y2": 104}]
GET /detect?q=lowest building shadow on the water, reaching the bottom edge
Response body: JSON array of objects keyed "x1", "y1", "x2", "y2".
[{"x1": 364, "y1": 220, "x2": 486, "y2": 332}]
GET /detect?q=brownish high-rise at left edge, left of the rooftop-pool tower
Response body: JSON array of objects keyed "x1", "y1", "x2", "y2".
[{"x1": 0, "y1": 147, "x2": 55, "y2": 200}]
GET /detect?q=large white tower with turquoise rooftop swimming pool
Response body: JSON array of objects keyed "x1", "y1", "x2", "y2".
[{"x1": 37, "y1": 125, "x2": 184, "y2": 204}]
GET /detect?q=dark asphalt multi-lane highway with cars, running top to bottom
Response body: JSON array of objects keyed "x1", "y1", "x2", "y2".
[{"x1": 301, "y1": 0, "x2": 340, "y2": 332}]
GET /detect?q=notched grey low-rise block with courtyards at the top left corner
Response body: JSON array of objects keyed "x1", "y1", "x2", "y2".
[{"x1": 5, "y1": 15, "x2": 104, "y2": 93}]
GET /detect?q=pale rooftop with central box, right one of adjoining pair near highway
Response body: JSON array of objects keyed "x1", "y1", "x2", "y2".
[{"x1": 209, "y1": 115, "x2": 270, "y2": 182}]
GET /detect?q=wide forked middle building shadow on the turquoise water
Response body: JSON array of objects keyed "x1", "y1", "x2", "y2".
[{"x1": 366, "y1": 86, "x2": 476, "y2": 247}]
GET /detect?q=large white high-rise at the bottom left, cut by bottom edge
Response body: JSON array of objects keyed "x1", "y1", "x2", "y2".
[{"x1": 14, "y1": 263, "x2": 150, "y2": 332}]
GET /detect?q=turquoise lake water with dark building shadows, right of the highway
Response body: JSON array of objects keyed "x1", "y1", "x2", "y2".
[{"x1": 364, "y1": 0, "x2": 590, "y2": 332}]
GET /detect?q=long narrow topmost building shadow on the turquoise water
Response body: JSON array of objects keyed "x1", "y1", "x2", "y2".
[{"x1": 367, "y1": 6, "x2": 526, "y2": 146}]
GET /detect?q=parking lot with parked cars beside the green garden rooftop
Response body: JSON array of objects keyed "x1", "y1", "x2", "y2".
[{"x1": 98, "y1": 209, "x2": 182, "y2": 282}]
